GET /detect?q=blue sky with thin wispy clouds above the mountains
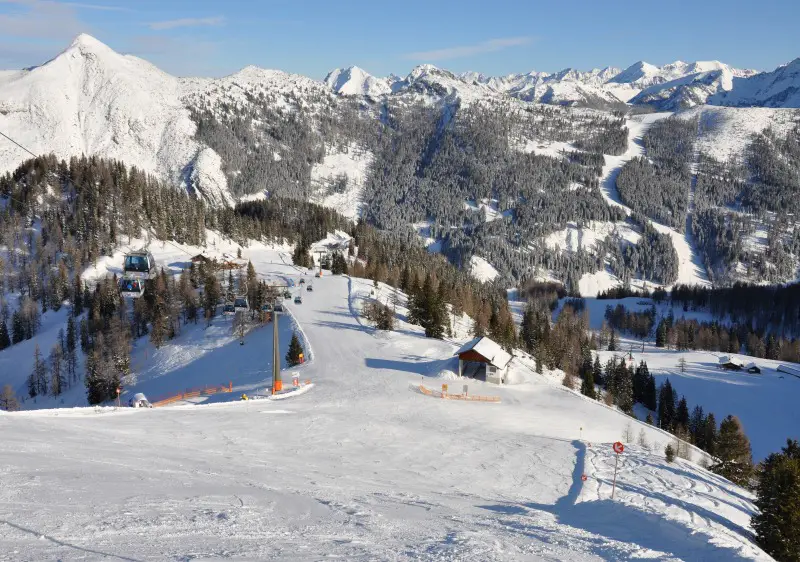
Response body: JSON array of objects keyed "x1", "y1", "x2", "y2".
[{"x1": 0, "y1": 0, "x2": 800, "y2": 78}]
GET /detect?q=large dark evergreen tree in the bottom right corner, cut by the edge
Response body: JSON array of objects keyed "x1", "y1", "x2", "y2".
[{"x1": 752, "y1": 439, "x2": 800, "y2": 562}]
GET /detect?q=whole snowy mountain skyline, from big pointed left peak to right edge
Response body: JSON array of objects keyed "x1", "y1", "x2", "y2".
[{"x1": 0, "y1": 34, "x2": 800, "y2": 210}]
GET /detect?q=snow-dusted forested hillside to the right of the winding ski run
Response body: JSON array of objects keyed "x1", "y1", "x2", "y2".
[{"x1": 692, "y1": 124, "x2": 800, "y2": 285}]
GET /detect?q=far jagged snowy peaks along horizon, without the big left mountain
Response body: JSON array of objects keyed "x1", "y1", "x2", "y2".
[{"x1": 325, "y1": 59, "x2": 800, "y2": 111}]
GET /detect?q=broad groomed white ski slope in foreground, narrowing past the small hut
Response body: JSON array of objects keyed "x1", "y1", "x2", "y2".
[{"x1": 0, "y1": 246, "x2": 770, "y2": 561}]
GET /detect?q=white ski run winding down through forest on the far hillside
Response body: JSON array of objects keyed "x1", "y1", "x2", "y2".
[{"x1": 600, "y1": 113, "x2": 710, "y2": 286}]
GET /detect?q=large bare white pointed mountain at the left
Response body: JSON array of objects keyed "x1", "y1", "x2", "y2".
[{"x1": 0, "y1": 35, "x2": 230, "y2": 204}]
